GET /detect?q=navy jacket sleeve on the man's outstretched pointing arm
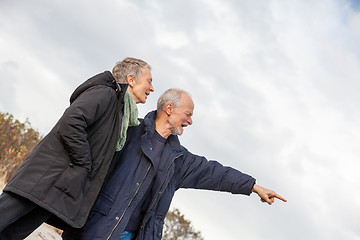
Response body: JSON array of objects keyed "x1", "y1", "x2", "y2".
[{"x1": 177, "y1": 152, "x2": 255, "y2": 195}]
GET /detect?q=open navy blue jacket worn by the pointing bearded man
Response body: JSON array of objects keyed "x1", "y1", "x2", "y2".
[{"x1": 83, "y1": 111, "x2": 255, "y2": 240}]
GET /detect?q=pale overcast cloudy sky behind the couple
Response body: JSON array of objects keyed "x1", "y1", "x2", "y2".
[{"x1": 0, "y1": 0, "x2": 360, "y2": 240}]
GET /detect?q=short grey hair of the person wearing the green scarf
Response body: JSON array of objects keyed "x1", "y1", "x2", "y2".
[{"x1": 112, "y1": 57, "x2": 151, "y2": 83}]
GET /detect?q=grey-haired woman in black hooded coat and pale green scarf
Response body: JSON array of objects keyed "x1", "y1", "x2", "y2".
[{"x1": 0, "y1": 58, "x2": 154, "y2": 239}]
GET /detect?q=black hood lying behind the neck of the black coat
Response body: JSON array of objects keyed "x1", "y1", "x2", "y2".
[{"x1": 70, "y1": 71, "x2": 127, "y2": 104}]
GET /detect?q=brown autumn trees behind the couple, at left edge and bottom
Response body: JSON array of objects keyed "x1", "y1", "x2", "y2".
[{"x1": 0, "y1": 112, "x2": 204, "y2": 240}]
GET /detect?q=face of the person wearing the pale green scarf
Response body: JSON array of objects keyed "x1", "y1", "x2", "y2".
[{"x1": 129, "y1": 68, "x2": 154, "y2": 103}]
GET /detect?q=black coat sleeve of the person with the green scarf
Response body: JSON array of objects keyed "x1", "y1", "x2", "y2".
[{"x1": 58, "y1": 85, "x2": 116, "y2": 171}]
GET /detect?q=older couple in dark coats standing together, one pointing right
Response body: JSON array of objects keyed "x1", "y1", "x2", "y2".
[{"x1": 0, "y1": 58, "x2": 286, "y2": 240}]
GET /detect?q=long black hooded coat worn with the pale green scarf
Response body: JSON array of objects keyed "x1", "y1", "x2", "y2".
[{"x1": 4, "y1": 71, "x2": 127, "y2": 227}]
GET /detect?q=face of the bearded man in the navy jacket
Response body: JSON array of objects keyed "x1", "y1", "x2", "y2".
[{"x1": 169, "y1": 94, "x2": 194, "y2": 135}]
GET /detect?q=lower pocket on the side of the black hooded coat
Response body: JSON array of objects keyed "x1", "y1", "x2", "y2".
[{"x1": 55, "y1": 164, "x2": 88, "y2": 199}]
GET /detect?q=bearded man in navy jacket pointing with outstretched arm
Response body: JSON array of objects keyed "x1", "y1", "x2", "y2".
[{"x1": 63, "y1": 89, "x2": 286, "y2": 240}]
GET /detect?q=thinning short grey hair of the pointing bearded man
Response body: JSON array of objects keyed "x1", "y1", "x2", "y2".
[{"x1": 157, "y1": 88, "x2": 191, "y2": 114}]
